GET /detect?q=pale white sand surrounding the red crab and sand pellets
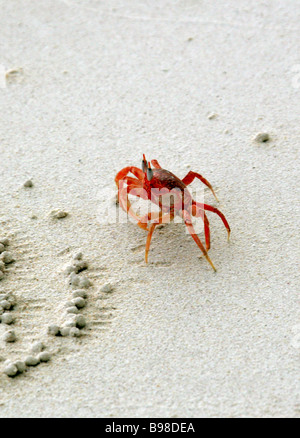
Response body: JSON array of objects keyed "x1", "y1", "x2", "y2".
[{"x1": 0, "y1": 0, "x2": 300, "y2": 417}]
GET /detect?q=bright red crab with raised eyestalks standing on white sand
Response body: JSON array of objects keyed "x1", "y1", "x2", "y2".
[{"x1": 115, "y1": 155, "x2": 230, "y2": 271}]
